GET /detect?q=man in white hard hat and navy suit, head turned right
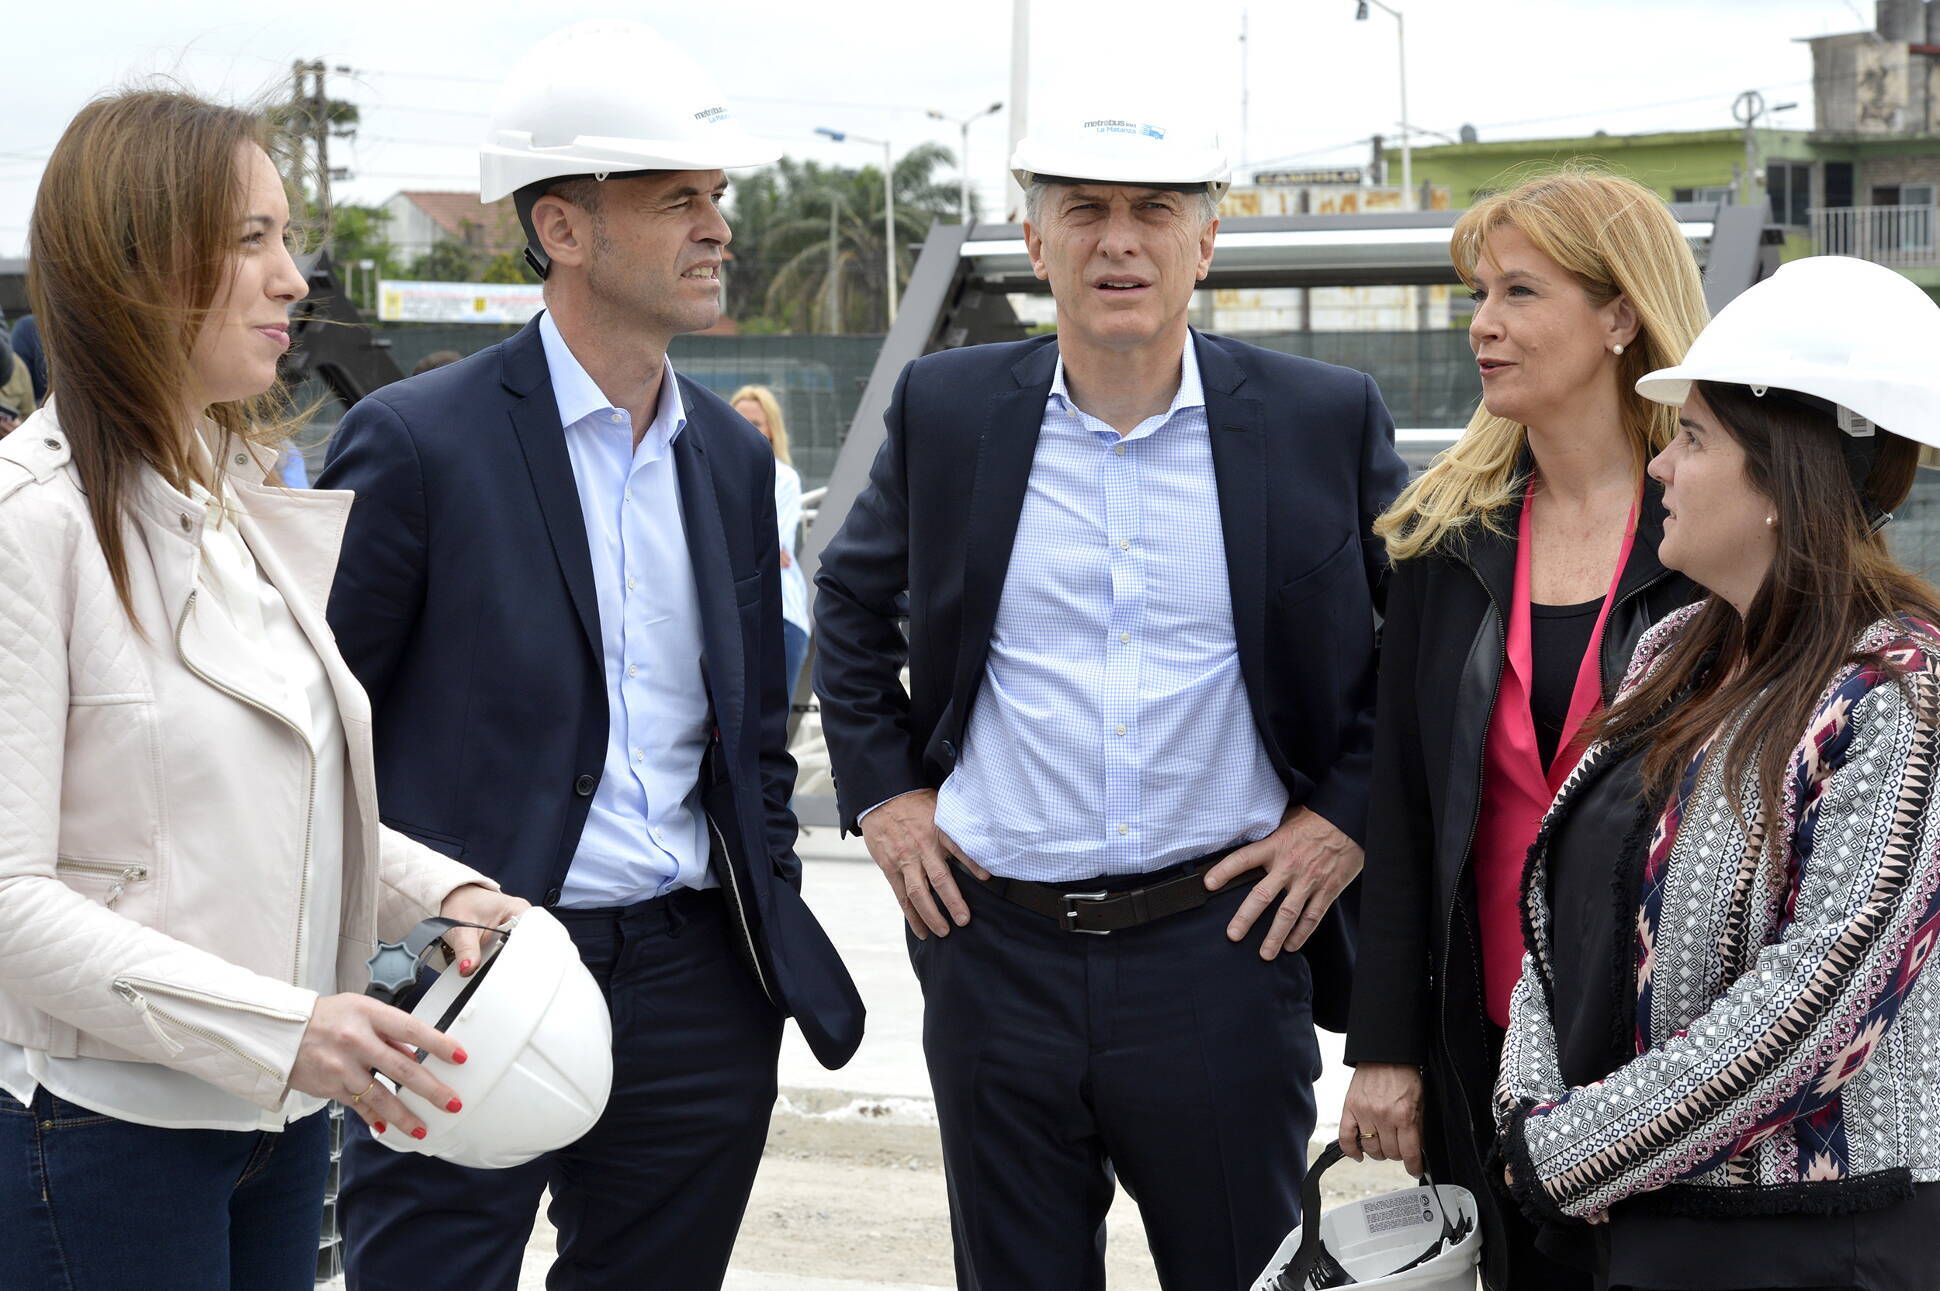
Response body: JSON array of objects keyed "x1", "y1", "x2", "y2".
[{"x1": 320, "y1": 21, "x2": 861, "y2": 1291}]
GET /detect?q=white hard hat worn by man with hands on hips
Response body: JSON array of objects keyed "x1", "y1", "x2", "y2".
[{"x1": 1011, "y1": 115, "x2": 1232, "y2": 202}]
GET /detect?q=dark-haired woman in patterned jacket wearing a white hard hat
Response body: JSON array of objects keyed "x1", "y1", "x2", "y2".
[{"x1": 1498, "y1": 256, "x2": 1940, "y2": 1291}]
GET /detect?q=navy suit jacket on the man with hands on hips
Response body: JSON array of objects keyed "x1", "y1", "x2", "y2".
[{"x1": 815, "y1": 332, "x2": 1407, "y2": 1031}]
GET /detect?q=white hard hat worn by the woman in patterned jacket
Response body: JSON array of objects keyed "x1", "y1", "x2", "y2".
[{"x1": 1637, "y1": 256, "x2": 1940, "y2": 464}]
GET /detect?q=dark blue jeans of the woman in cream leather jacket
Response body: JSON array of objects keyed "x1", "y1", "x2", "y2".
[{"x1": 0, "y1": 1089, "x2": 330, "y2": 1291}]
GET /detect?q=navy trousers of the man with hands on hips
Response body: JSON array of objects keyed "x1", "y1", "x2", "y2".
[{"x1": 910, "y1": 876, "x2": 1321, "y2": 1291}]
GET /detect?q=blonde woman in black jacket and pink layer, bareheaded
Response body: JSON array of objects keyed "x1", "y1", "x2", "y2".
[{"x1": 1341, "y1": 173, "x2": 1705, "y2": 1291}]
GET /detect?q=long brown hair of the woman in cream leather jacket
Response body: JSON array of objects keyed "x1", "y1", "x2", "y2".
[{"x1": 27, "y1": 89, "x2": 298, "y2": 617}]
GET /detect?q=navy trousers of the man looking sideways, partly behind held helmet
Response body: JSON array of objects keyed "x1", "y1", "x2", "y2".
[{"x1": 338, "y1": 891, "x2": 782, "y2": 1291}]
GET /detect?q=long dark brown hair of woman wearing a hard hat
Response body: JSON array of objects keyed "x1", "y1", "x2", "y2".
[{"x1": 1599, "y1": 382, "x2": 1940, "y2": 810}]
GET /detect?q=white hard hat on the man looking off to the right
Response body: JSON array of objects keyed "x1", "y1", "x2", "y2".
[{"x1": 479, "y1": 21, "x2": 782, "y2": 202}]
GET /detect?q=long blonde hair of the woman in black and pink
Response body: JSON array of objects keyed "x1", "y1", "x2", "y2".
[{"x1": 1374, "y1": 165, "x2": 1707, "y2": 561}]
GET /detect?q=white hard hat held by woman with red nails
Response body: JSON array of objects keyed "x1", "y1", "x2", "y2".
[{"x1": 364, "y1": 909, "x2": 613, "y2": 1169}]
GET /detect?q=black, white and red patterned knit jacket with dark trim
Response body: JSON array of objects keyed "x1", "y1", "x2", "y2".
[{"x1": 1496, "y1": 606, "x2": 1940, "y2": 1219}]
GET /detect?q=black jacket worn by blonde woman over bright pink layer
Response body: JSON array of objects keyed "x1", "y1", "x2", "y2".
[{"x1": 1346, "y1": 480, "x2": 1699, "y2": 1289}]
